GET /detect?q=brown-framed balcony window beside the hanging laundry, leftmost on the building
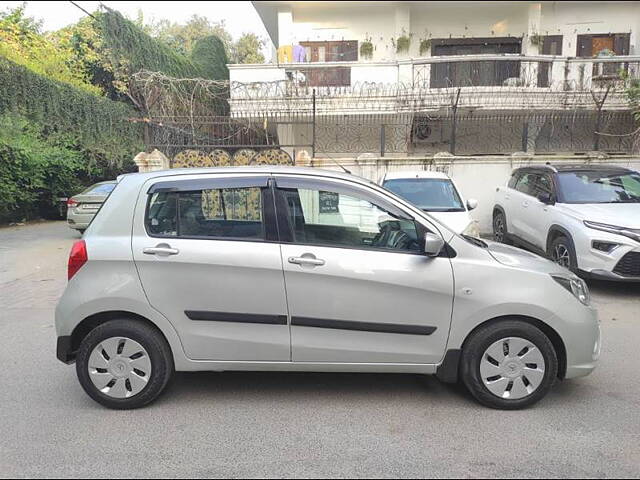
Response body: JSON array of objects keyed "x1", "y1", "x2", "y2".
[{"x1": 300, "y1": 40, "x2": 358, "y2": 87}]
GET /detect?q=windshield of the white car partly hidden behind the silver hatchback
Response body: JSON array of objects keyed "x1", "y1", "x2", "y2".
[{"x1": 383, "y1": 178, "x2": 464, "y2": 212}]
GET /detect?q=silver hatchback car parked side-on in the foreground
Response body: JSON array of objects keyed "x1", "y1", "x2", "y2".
[{"x1": 56, "y1": 167, "x2": 600, "y2": 409}]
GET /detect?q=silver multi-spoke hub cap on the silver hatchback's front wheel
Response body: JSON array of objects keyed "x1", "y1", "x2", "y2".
[{"x1": 480, "y1": 337, "x2": 545, "y2": 400}]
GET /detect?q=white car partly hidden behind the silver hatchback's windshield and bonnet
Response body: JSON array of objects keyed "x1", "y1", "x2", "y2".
[{"x1": 380, "y1": 170, "x2": 480, "y2": 237}]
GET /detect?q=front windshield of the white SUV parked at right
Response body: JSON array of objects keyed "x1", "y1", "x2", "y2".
[{"x1": 558, "y1": 171, "x2": 640, "y2": 203}]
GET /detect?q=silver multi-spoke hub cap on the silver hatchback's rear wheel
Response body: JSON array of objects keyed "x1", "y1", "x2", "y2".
[{"x1": 87, "y1": 337, "x2": 151, "y2": 398}]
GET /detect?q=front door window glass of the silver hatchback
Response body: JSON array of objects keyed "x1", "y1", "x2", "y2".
[{"x1": 280, "y1": 188, "x2": 420, "y2": 252}]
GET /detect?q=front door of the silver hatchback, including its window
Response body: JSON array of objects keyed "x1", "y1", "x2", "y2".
[{"x1": 276, "y1": 176, "x2": 453, "y2": 363}]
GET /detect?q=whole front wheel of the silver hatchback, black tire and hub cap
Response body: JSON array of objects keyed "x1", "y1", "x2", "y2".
[{"x1": 460, "y1": 320, "x2": 558, "y2": 410}]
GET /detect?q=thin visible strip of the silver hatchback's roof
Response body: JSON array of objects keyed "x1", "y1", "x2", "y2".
[{"x1": 118, "y1": 165, "x2": 375, "y2": 185}]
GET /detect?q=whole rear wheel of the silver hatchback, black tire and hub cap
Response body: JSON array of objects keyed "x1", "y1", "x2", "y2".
[{"x1": 76, "y1": 319, "x2": 174, "y2": 410}]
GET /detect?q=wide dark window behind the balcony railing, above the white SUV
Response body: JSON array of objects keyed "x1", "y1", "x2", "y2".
[{"x1": 431, "y1": 37, "x2": 521, "y2": 88}]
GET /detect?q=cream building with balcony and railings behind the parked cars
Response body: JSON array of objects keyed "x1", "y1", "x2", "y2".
[{"x1": 229, "y1": 1, "x2": 640, "y2": 230}]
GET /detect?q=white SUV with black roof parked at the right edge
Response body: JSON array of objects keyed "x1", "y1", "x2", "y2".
[{"x1": 493, "y1": 165, "x2": 640, "y2": 281}]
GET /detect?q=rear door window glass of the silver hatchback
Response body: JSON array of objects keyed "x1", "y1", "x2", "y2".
[{"x1": 147, "y1": 187, "x2": 264, "y2": 239}]
